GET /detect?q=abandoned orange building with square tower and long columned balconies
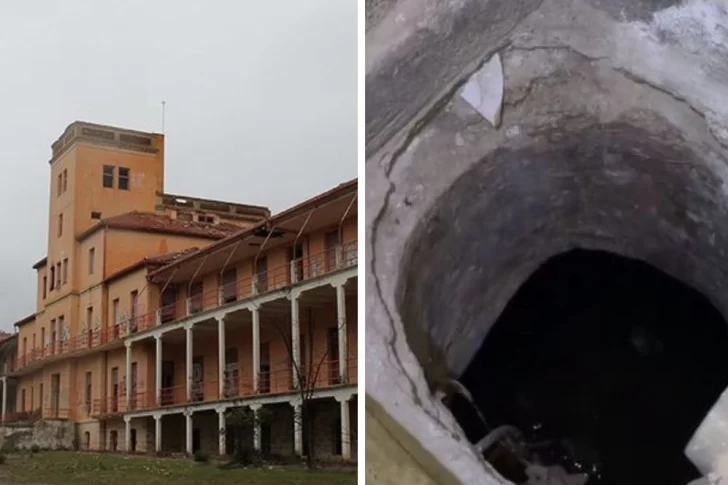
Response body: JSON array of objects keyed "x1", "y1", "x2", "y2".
[{"x1": 0, "y1": 122, "x2": 358, "y2": 460}]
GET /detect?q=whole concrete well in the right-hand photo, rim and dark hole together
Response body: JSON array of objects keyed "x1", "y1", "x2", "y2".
[{"x1": 365, "y1": 0, "x2": 728, "y2": 485}]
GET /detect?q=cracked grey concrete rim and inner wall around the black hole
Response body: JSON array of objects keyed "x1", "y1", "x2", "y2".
[{"x1": 366, "y1": 0, "x2": 728, "y2": 484}]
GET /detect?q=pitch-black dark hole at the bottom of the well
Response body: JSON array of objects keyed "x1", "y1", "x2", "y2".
[{"x1": 453, "y1": 250, "x2": 728, "y2": 485}]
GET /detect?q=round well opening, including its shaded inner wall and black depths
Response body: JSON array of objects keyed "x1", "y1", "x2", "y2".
[{"x1": 397, "y1": 119, "x2": 728, "y2": 485}]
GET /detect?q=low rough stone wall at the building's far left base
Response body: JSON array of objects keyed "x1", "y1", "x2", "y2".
[{"x1": 0, "y1": 420, "x2": 76, "y2": 450}]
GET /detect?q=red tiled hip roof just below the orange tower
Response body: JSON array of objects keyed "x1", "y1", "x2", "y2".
[{"x1": 78, "y1": 211, "x2": 242, "y2": 241}]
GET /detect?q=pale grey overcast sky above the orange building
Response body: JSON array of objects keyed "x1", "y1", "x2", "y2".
[{"x1": 0, "y1": 0, "x2": 357, "y2": 330}]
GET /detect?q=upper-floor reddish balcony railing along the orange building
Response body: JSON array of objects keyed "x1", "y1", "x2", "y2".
[{"x1": 12, "y1": 241, "x2": 358, "y2": 372}]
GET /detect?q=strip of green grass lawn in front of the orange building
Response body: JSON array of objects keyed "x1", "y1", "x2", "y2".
[{"x1": 0, "y1": 451, "x2": 356, "y2": 485}]
